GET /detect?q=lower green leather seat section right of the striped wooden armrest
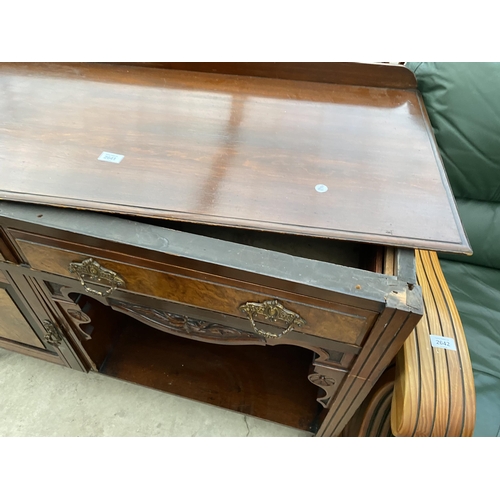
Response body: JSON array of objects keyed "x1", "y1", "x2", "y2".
[{"x1": 441, "y1": 260, "x2": 500, "y2": 436}]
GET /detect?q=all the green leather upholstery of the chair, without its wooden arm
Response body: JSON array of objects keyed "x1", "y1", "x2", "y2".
[{"x1": 406, "y1": 62, "x2": 500, "y2": 436}]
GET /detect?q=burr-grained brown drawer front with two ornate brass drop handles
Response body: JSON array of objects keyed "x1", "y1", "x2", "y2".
[{"x1": 16, "y1": 236, "x2": 376, "y2": 345}]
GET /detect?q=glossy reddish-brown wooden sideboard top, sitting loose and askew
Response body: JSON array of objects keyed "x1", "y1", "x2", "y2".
[{"x1": 0, "y1": 64, "x2": 470, "y2": 253}]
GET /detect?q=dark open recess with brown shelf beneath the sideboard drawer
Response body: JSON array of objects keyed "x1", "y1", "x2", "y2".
[{"x1": 74, "y1": 299, "x2": 322, "y2": 432}]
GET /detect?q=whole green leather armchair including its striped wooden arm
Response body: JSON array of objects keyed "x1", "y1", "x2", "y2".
[{"x1": 343, "y1": 62, "x2": 500, "y2": 436}]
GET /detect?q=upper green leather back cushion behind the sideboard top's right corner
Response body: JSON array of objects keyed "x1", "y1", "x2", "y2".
[{"x1": 406, "y1": 63, "x2": 500, "y2": 202}]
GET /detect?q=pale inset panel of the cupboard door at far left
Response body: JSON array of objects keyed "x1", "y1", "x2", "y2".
[{"x1": 0, "y1": 288, "x2": 44, "y2": 349}]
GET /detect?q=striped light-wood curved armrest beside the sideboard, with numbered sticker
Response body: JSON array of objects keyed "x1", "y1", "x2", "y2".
[{"x1": 391, "y1": 251, "x2": 476, "y2": 437}]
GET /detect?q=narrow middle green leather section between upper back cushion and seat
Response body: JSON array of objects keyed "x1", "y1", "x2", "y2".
[{"x1": 439, "y1": 198, "x2": 500, "y2": 269}]
